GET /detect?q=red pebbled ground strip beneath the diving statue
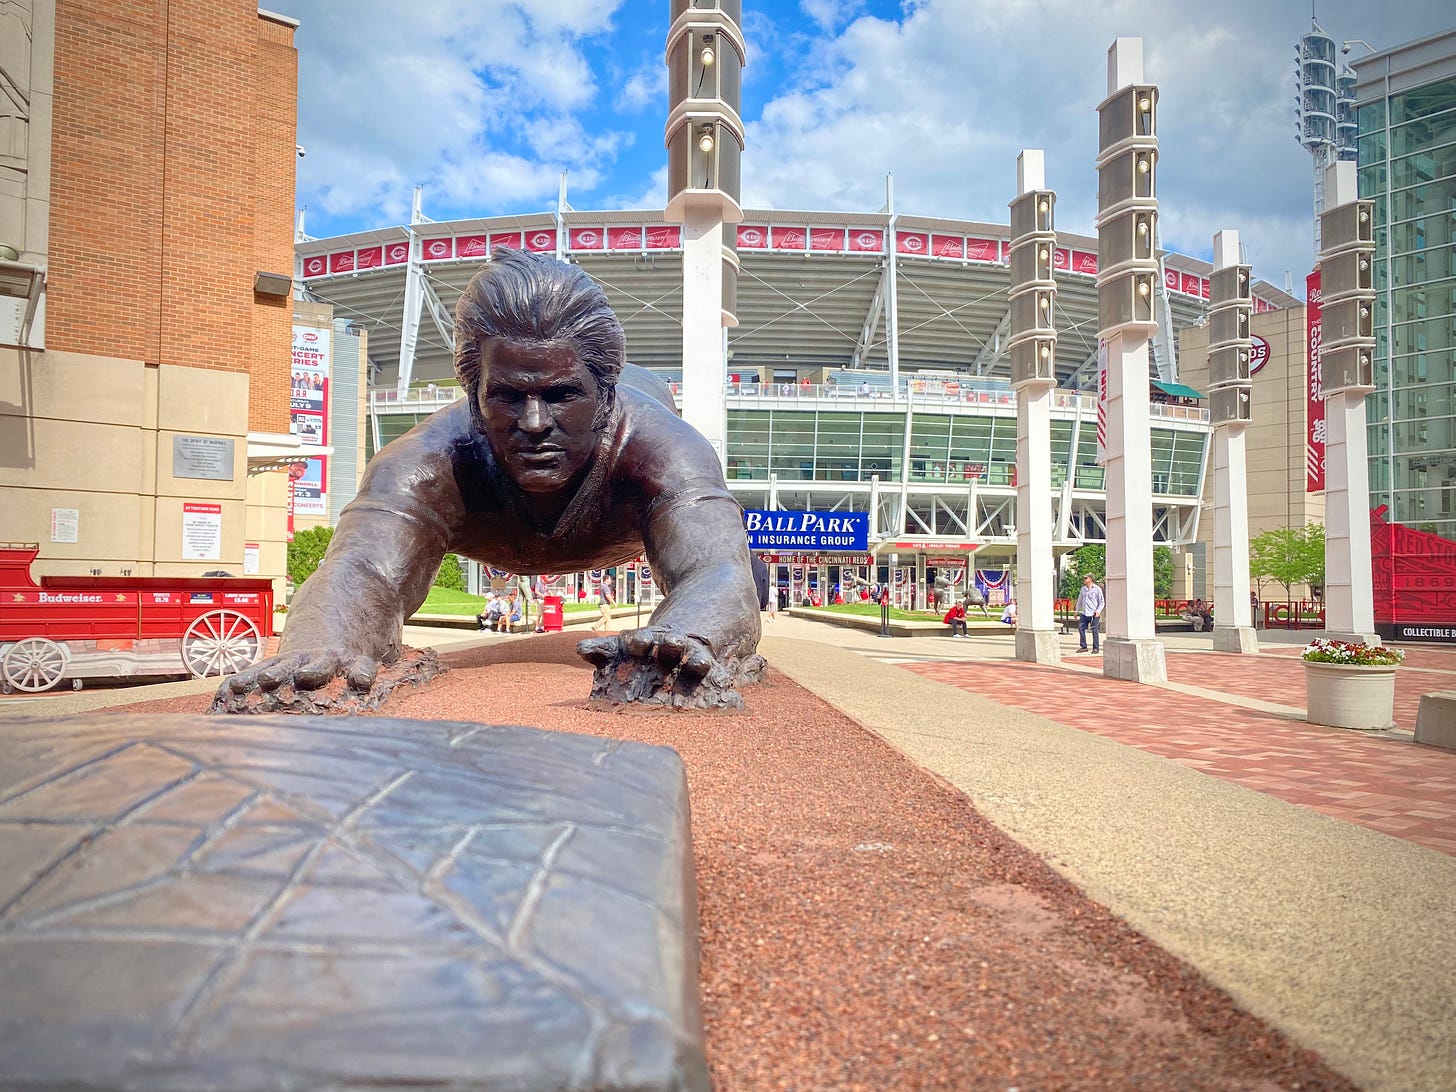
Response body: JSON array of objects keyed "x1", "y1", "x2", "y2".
[{"x1": 119, "y1": 635, "x2": 1353, "y2": 1092}]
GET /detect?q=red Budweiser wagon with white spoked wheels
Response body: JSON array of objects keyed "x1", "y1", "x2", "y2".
[{"x1": 0, "y1": 543, "x2": 272, "y2": 693}]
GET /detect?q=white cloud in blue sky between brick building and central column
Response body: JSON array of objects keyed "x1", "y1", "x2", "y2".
[{"x1": 284, "y1": 0, "x2": 628, "y2": 221}]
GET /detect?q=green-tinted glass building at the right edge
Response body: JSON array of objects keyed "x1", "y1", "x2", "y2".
[{"x1": 1356, "y1": 31, "x2": 1456, "y2": 539}]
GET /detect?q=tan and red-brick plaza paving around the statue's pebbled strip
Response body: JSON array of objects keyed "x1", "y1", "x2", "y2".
[{"x1": 0, "y1": 613, "x2": 1456, "y2": 1089}]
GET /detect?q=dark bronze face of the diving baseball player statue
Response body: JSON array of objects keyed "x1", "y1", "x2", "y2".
[{"x1": 476, "y1": 339, "x2": 601, "y2": 494}]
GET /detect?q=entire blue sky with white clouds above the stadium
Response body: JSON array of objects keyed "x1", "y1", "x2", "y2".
[{"x1": 269, "y1": 0, "x2": 1456, "y2": 296}]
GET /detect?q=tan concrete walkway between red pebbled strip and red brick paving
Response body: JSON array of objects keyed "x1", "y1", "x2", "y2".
[{"x1": 760, "y1": 619, "x2": 1456, "y2": 1091}]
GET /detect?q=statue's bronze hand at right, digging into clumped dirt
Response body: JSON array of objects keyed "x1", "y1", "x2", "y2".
[{"x1": 577, "y1": 623, "x2": 763, "y2": 709}]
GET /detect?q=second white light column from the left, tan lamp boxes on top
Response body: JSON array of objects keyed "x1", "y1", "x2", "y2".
[{"x1": 1009, "y1": 149, "x2": 1061, "y2": 664}]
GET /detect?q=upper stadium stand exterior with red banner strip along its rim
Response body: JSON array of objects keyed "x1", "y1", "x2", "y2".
[{"x1": 296, "y1": 204, "x2": 1299, "y2": 387}]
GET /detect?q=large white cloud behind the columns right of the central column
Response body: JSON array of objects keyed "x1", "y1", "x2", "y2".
[{"x1": 744, "y1": 0, "x2": 1447, "y2": 295}]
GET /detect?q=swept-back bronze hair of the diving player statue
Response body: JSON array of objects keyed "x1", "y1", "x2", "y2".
[{"x1": 454, "y1": 246, "x2": 626, "y2": 428}]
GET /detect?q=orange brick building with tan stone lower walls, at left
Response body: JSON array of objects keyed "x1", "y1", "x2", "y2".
[{"x1": 0, "y1": 0, "x2": 298, "y2": 591}]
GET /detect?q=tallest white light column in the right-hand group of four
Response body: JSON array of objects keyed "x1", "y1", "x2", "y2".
[{"x1": 1096, "y1": 38, "x2": 1168, "y2": 683}]
